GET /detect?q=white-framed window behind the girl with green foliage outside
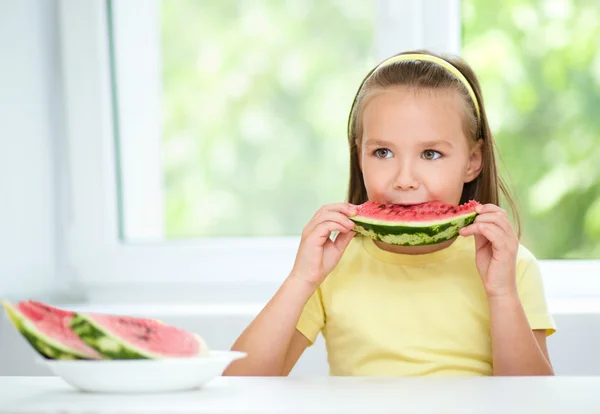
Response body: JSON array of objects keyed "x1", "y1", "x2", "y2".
[{"x1": 60, "y1": 0, "x2": 600, "y2": 300}]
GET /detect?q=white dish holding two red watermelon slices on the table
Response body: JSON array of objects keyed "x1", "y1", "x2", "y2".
[{"x1": 3, "y1": 301, "x2": 246, "y2": 393}]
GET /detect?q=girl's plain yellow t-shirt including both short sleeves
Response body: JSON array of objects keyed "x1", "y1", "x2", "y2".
[{"x1": 297, "y1": 235, "x2": 555, "y2": 376}]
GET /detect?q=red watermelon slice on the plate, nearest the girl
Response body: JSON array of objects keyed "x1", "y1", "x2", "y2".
[{"x1": 71, "y1": 313, "x2": 209, "y2": 359}]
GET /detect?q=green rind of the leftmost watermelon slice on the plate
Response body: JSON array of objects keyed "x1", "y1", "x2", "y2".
[{"x1": 2, "y1": 301, "x2": 95, "y2": 360}]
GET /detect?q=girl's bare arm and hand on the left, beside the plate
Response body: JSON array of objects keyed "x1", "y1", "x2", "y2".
[{"x1": 224, "y1": 203, "x2": 356, "y2": 376}]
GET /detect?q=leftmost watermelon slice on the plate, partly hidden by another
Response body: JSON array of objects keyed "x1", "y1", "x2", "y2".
[{"x1": 2, "y1": 301, "x2": 103, "y2": 359}]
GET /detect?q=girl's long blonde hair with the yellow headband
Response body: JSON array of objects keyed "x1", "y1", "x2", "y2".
[{"x1": 348, "y1": 50, "x2": 521, "y2": 236}]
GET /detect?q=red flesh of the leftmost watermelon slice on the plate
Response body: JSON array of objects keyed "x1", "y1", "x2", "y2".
[{"x1": 10, "y1": 301, "x2": 102, "y2": 359}]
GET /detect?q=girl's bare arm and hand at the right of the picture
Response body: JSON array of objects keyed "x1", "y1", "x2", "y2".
[{"x1": 460, "y1": 204, "x2": 554, "y2": 375}]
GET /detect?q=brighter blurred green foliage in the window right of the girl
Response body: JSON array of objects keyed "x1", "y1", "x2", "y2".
[{"x1": 462, "y1": 0, "x2": 600, "y2": 259}]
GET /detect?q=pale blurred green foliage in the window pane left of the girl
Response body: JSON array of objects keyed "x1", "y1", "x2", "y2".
[{"x1": 162, "y1": 0, "x2": 375, "y2": 238}]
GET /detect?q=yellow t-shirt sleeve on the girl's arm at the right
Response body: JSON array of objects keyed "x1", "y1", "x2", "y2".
[{"x1": 517, "y1": 246, "x2": 556, "y2": 336}]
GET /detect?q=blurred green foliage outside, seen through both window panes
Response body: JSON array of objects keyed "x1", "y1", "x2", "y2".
[{"x1": 162, "y1": 0, "x2": 600, "y2": 258}]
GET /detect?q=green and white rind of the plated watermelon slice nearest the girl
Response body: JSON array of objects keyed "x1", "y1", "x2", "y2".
[{"x1": 71, "y1": 313, "x2": 207, "y2": 359}]
